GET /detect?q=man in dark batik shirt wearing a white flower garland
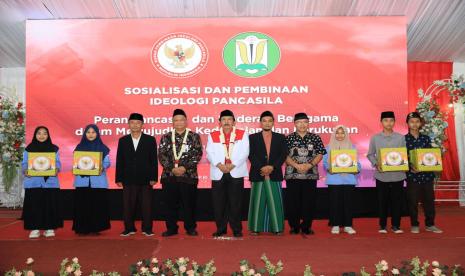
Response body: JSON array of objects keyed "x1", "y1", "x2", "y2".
[{"x1": 158, "y1": 109, "x2": 202, "y2": 237}]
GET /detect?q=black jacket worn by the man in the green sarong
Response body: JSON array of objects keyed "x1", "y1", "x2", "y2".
[{"x1": 249, "y1": 131, "x2": 287, "y2": 182}]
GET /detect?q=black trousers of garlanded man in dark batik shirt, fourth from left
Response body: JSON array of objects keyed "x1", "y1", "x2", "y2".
[{"x1": 162, "y1": 179, "x2": 197, "y2": 232}]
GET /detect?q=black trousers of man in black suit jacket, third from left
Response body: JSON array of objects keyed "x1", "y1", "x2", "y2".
[{"x1": 123, "y1": 184, "x2": 153, "y2": 232}]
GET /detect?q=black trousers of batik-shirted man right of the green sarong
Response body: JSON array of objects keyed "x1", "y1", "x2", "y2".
[{"x1": 285, "y1": 179, "x2": 316, "y2": 230}]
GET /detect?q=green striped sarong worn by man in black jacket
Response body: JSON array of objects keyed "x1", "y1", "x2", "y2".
[{"x1": 248, "y1": 180, "x2": 284, "y2": 233}]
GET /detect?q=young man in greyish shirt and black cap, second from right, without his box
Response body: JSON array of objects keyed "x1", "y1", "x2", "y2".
[{"x1": 367, "y1": 111, "x2": 405, "y2": 234}]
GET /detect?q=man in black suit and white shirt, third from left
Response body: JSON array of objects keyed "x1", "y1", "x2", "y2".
[{"x1": 115, "y1": 113, "x2": 158, "y2": 237}]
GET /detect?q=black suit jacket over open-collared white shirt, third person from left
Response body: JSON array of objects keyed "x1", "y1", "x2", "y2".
[{"x1": 115, "y1": 133, "x2": 158, "y2": 185}]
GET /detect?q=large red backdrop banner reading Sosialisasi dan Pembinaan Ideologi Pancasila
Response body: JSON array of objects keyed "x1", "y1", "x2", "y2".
[{"x1": 26, "y1": 16, "x2": 408, "y2": 188}]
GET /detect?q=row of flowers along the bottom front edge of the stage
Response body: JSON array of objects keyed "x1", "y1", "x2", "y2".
[{"x1": 4, "y1": 254, "x2": 465, "y2": 276}]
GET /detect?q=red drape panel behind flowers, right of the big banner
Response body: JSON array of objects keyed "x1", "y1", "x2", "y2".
[{"x1": 407, "y1": 62, "x2": 460, "y2": 201}]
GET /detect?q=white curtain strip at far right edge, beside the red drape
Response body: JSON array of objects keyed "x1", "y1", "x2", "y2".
[{"x1": 452, "y1": 62, "x2": 465, "y2": 206}]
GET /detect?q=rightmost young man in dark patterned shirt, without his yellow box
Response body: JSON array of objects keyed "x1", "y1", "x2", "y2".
[{"x1": 405, "y1": 112, "x2": 442, "y2": 234}]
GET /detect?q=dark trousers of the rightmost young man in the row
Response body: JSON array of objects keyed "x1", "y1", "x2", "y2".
[{"x1": 407, "y1": 181, "x2": 436, "y2": 226}]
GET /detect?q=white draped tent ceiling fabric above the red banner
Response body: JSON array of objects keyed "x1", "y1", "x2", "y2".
[{"x1": 0, "y1": 0, "x2": 465, "y2": 67}]
